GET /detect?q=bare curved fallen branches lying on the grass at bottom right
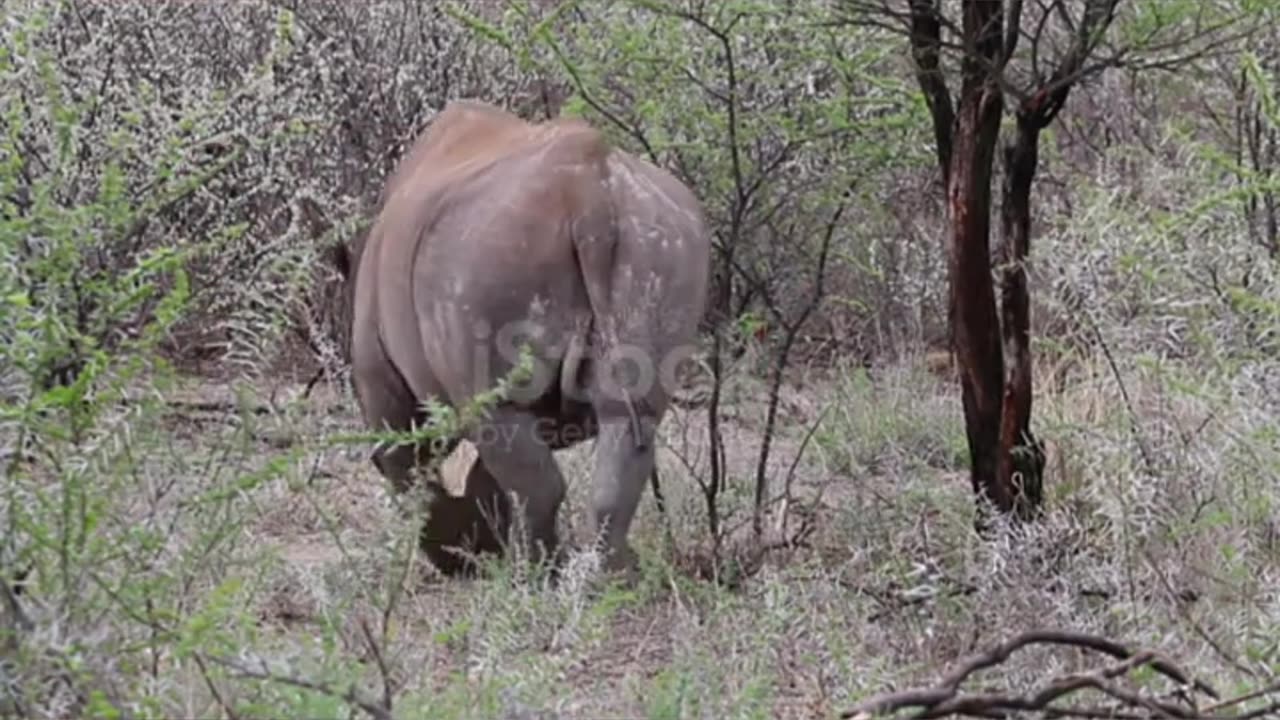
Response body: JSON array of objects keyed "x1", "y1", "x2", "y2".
[{"x1": 841, "y1": 630, "x2": 1218, "y2": 720}]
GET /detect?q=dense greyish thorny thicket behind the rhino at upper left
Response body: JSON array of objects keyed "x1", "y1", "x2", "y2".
[{"x1": 4, "y1": 0, "x2": 550, "y2": 386}]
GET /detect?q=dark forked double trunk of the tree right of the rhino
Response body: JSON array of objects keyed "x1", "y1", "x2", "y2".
[{"x1": 870, "y1": 0, "x2": 1172, "y2": 530}]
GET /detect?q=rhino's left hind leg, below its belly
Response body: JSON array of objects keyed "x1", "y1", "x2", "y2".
[{"x1": 472, "y1": 407, "x2": 566, "y2": 561}]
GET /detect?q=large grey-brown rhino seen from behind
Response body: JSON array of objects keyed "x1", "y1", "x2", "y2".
[{"x1": 338, "y1": 101, "x2": 710, "y2": 570}]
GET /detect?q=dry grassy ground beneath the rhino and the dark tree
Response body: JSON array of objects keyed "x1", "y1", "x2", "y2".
[{"x1": 10, "y1": 340, "x2": 1259, "y2": 717}]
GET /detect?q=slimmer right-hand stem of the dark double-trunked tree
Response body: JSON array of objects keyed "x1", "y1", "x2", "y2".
[{"x1": 997, "y1": 113, "x2": 1044, "y2": 519}]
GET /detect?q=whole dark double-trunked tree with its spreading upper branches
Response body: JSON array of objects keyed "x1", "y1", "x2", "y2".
[{"x1": 844, "y1": 0, "x2": 1249, "y2": 520}]
